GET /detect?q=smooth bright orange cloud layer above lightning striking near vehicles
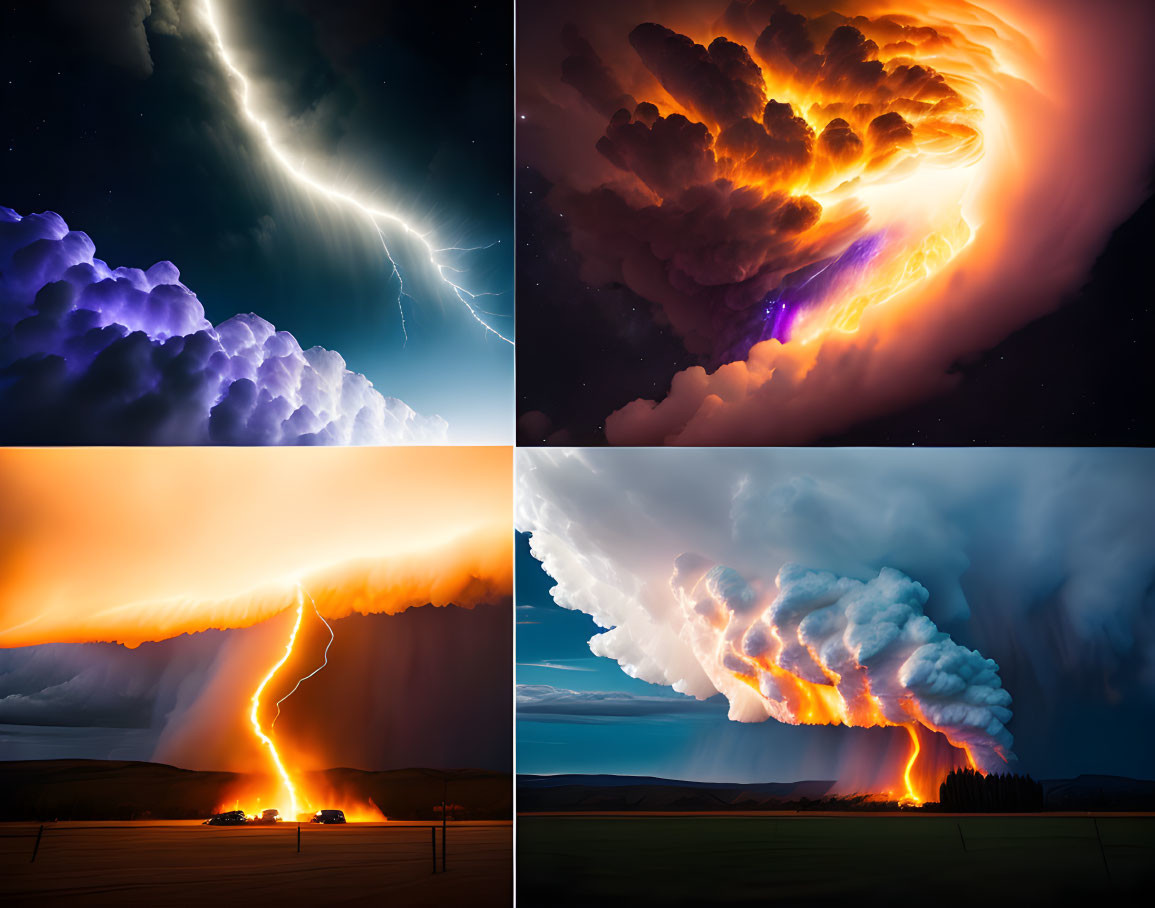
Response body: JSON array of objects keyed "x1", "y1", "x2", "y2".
[{"x1": 0, "y1": 448, "x2": 513, "y2": 647}]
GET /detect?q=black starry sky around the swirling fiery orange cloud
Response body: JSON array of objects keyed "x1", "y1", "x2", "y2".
[{"x1": 516, "y1": 2, "x2": 1155, "y2": 446}]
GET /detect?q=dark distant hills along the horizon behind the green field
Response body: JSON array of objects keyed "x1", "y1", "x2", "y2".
[{"x1": 517, "y1": 775, "x2": 1155, "y2": 813}]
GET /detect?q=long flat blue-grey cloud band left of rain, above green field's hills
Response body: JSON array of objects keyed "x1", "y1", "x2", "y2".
[{"x1": 517, "y1": 684, "x2": 725, "y2": 723}]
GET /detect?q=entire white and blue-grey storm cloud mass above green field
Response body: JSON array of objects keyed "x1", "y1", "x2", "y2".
[{"x1": 516, "y1": 449, "x2": 1155, "y2": 771}]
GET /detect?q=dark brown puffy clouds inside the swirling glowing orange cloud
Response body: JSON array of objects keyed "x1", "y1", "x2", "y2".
[{"x1": 538, "y1": 3, "x2": 954, "y2": 367}]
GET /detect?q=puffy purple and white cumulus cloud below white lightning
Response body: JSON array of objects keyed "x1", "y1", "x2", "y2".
[{"x1": 0, "y1": 207, "x2": 447, "y2": 445}]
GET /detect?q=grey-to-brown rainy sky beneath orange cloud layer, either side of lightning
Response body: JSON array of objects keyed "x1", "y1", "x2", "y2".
[{"x1": 0, "y1": 605, "x2": 513, "y2": 771}]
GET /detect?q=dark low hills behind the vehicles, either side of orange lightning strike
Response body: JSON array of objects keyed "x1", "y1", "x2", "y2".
[{"x1": 0, "y1": 760, "x2": 513, "y2": 820}]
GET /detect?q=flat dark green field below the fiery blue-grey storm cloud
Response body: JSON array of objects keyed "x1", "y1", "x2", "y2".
[{"x1": 517, "y1": 814, "x2": 1155, "y2": 908}]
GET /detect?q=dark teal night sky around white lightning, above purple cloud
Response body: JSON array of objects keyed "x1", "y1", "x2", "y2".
[{"x1": 0, "y1": 0, "x2": 513, "y2": 441}]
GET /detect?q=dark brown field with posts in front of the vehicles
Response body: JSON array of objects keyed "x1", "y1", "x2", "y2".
[{"x1": 0, "y1": 820, "x2": 513, "y2": 908}]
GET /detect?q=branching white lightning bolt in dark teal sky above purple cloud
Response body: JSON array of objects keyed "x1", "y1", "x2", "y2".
[{"x1": 201, "y1": 0, "x2": 513, "y2": 345}]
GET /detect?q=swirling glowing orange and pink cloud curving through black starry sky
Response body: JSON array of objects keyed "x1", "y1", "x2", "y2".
[{"x1": 542, "y1": 0, "x2": 1155, "y2": 445}]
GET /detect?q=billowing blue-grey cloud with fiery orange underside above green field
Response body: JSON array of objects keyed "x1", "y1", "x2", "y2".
[{"x1": 672, "y1": 556, "x2": 1013, "y2": 772}]
